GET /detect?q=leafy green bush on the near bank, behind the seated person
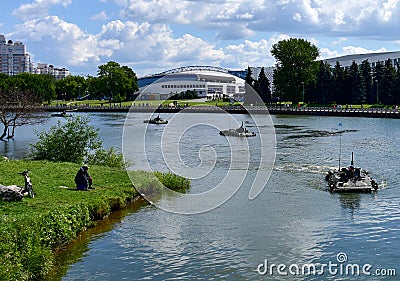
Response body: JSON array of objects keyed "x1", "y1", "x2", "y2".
[{"x1": 31, "y1": 116, "x2": 102, "y2": 163}]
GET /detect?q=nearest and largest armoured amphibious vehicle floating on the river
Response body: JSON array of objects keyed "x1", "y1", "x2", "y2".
[{"x1": 325, "y1": 153, "x2": 378, "y2": 193}]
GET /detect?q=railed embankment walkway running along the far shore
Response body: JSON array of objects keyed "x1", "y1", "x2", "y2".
[{"x1": 41, "y1": 104, "x2": 400, "y2": 118}]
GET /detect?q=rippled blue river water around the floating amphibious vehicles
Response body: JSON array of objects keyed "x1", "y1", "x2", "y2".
[{"x1": 0, "y1": 110, "x2": 400, "y2": 280}]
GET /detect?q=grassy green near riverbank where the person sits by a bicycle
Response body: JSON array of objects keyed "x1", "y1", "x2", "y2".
[{"x1": 0, "y1": 161, "x2": 190, "y2": 280}]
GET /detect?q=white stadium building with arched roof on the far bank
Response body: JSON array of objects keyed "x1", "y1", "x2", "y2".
[{"x1": 138, "y1": 66, "x2": 245, "y2": 100}]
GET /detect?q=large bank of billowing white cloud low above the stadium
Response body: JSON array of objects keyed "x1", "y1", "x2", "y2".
[{"x1": 9, "y1": 13, "x2": 282, "y2": 75}]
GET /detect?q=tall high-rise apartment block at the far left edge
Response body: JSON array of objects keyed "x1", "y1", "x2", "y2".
[{"x1": 0, "y1": 34, "x2": 31, "y2": 75}]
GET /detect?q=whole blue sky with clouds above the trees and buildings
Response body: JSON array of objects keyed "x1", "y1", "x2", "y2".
[{"x1": 0, "y1": 0, "x2": 400, "y2": 76}]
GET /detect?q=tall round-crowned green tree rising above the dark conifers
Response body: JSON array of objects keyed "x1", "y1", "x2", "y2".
[{"x1": 271, "y1": 38, "x2": 319, "y2": 102}]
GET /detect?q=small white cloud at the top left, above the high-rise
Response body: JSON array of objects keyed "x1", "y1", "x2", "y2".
[{"x1": 12, "y1": 0, "x2": 72, "y2": 20}]
